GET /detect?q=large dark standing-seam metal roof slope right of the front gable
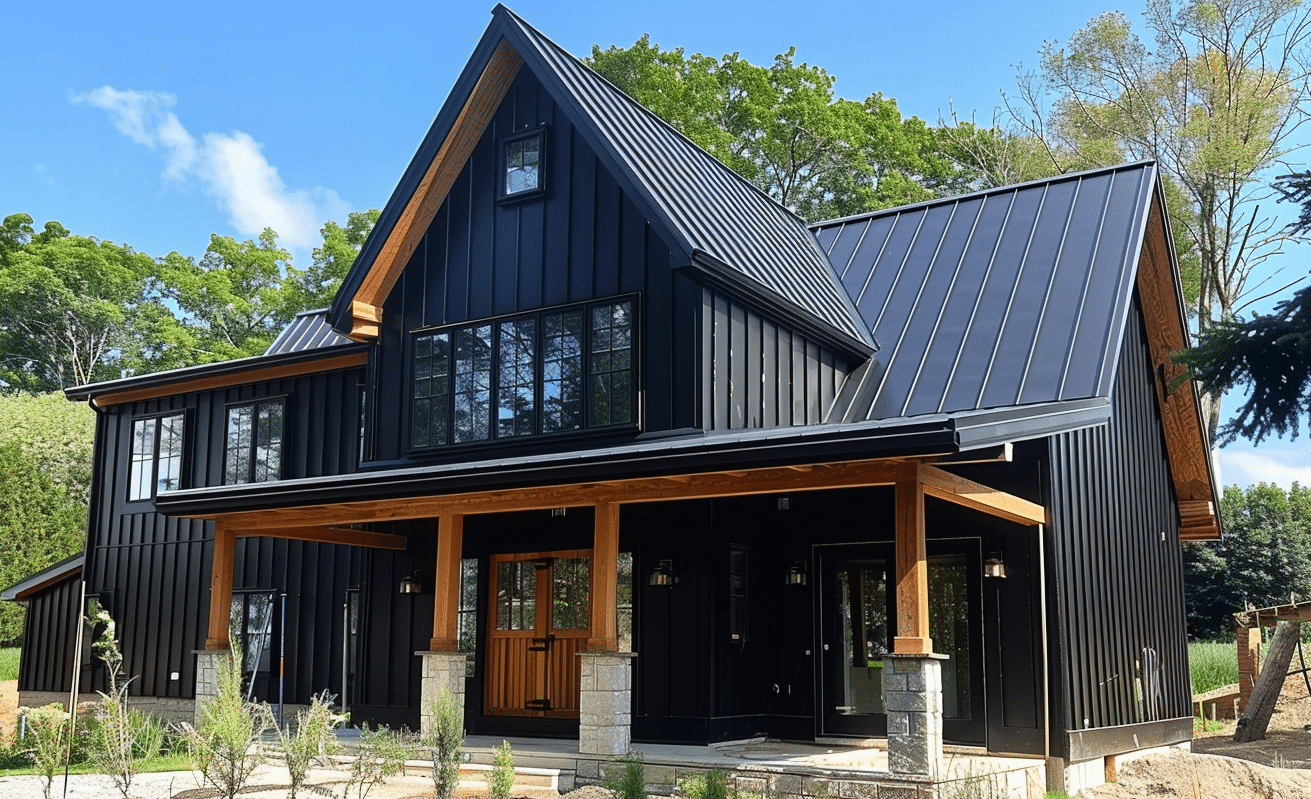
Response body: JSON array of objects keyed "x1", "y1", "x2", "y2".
[{"x1": 813, "y1": 163, "x2": 1156, "y2": 421}]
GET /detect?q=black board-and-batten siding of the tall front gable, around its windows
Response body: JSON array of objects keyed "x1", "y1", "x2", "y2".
[{"x1": 372, "y1": 70, "x2": 718, "y2": 462}]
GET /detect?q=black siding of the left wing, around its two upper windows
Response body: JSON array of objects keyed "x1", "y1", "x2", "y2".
[{"x1": 84, "y1": 369, "x2": 364, "y2": 702}]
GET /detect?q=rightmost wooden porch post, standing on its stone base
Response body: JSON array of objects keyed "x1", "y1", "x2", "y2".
[{"x1": 893, "y1": 464, "x2": 933, "y2": 655}]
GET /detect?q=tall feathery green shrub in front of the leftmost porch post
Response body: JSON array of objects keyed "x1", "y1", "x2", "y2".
[{"x1": 182, "y1": 642, "x2": 273, "y2": 799}]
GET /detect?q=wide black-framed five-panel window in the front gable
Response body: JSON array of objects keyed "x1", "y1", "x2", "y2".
[{"x1": 410, "y1": 298, "x2": 636, "y2": 447}]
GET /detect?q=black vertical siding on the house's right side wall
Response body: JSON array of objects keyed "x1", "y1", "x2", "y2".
[{"x1": 1047, "y1": 302, "x2": 1192, "y2": 760}]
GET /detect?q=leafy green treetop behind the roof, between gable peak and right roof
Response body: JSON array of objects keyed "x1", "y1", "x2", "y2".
[{"x1": 590, "y1": 37, "x2": 953, "y2": 219}]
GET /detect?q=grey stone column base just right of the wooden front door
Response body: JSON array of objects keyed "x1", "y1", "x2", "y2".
[{"x1": 578, "y1": 652, "x2": 637, "y2": 756}]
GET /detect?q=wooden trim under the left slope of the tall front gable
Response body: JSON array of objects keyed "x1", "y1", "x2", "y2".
[{"x1": 350, "y1": 39, "x2": 523, "y2": 330}]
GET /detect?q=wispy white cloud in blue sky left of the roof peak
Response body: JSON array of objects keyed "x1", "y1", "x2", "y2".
[{"x1": 71, "y1": 85, "x2": 350, "y2": 260}]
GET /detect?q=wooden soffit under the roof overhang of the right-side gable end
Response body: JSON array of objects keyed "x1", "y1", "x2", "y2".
[{"x1": 1137, "y1": 199, "x2": 1219, "y2": 541}]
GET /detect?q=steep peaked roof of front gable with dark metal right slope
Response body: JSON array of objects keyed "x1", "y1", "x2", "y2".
[{"x1": 328, "y1": 5, "x2": 874, "y2": 353}]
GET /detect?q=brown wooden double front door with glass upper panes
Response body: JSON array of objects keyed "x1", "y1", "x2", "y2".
[{"x1": 484, "y1": 550, "x2": 591, "y2": 719}]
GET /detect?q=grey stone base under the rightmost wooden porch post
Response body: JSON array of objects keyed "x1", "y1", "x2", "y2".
[{"x1": 884, "y1": 655, "x2": 947, "y2": 779}]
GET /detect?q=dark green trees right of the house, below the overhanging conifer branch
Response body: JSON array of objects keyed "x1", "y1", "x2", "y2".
[{"x1": 1184, "y1": 483, "x2": 1311, "y2": 640}]
